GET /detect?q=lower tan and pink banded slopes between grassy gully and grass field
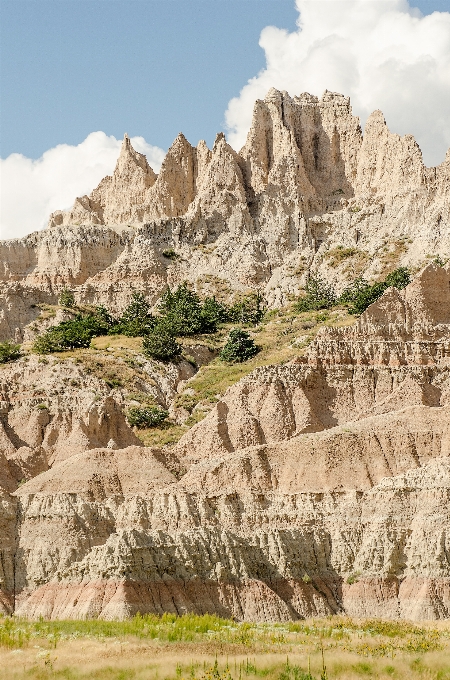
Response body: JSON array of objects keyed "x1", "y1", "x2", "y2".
[{"x1": 0, "y1": 264, "x2": 450, "y2": 621}]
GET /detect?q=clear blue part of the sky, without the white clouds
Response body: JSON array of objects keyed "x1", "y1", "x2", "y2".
[{"x1": 0, "y1": 0, "x2": 450, "y2": 158}]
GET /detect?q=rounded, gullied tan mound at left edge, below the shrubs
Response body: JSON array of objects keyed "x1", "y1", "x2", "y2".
[{"x1": 0, "y1": 357, "x2": 139, "y2": 470}]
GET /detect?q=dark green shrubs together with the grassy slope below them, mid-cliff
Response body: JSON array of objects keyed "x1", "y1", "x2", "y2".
[{"x1": 19, "y1": 268, "x2": 409, "y2": 446}]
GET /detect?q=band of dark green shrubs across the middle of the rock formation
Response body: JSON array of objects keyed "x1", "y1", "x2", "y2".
[{"x1": 27, "y1": 267, "x2": 411, "y2": 361}]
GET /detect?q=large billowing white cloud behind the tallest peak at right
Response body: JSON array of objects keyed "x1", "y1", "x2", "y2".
[{"x1": 226, "y1": 0, "x2": 450, "y2": 165}]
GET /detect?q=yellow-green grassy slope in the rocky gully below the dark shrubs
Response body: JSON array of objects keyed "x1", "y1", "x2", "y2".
[{"x1": 24, "y1": 307, "x2": 354, "y2": 446}]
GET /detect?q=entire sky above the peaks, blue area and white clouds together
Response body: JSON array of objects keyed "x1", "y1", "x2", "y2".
[{"x1": 0, "y1": 0, "x2": 450, "y2": 238}]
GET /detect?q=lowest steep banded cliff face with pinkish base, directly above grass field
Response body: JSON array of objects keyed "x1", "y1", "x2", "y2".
[{"x1": 9, "y1": 454, "x2": 450, "y2": 621}]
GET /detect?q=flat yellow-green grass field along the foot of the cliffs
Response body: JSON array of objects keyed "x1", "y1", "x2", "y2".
[{"x1": 0, "y1": 614, "x2": 450, "y2": 680}]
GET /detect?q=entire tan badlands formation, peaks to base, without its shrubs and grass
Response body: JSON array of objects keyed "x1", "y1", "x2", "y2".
[{"x1": 0, "y1": 90, "x2": 450, "y2": 621}]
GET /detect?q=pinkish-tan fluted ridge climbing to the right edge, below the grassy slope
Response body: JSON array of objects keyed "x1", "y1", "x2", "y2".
[{"x1": 172, "y1": 264, "x2": 450, "y2": 462}]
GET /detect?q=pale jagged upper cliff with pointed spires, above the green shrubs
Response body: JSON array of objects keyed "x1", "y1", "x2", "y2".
[{"x1": 0, "y1": 90, "x2": 450, "y2": 341}]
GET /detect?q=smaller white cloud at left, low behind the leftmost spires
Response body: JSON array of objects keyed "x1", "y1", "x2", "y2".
[{"x1": 0, "y1": 132, "x2": 165, "y2": 239}]
